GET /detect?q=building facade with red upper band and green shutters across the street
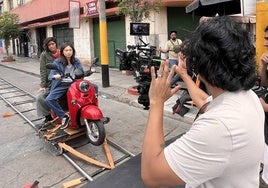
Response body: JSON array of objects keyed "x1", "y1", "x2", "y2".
[{"x1": 0, "y1": 0, "x2": 255, "y2": 67}]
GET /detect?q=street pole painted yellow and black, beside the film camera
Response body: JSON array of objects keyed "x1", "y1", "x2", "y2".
[{"x1": 99, "y1": 0, "x2": 110, "y2": 87}]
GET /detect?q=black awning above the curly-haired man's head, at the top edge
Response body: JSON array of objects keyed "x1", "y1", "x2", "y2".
[{"x1": 186, "y1": 0, "x2": 241, "y2": 16}]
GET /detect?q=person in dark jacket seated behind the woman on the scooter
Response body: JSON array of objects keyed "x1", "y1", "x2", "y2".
[{"x1": 36, "y1": 37, "x2": 60, "y2": 124}]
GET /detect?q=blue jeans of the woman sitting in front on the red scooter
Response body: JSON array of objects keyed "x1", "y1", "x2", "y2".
[{"x1": 46, "y1": 86, "x2": 70, "y2": 118}]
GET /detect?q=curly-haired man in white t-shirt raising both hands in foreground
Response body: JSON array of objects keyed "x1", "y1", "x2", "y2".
[{"x1": 141, "y1": 17, "x2": 264, "y2": 188}]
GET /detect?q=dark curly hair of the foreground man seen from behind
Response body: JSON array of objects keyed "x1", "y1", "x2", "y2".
[{"x1": 185, "y1": 16, "x2": 256, "y2": 91}]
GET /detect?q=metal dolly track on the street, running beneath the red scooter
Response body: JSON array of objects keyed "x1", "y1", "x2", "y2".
[{"x1": 0, "y1": 78, "x2": 134, "y2": 184}]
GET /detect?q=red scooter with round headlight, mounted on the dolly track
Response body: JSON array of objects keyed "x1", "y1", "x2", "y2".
[{"x1": 42, "y1": 59, "x2": 110, "y2": 146}]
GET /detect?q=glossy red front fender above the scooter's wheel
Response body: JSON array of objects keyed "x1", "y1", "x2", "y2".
[{"x1": 81, "y1": 105, "x2": 103, "y2": 120}]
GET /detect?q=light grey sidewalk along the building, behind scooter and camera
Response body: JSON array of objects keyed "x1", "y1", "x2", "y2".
[{"x1": 0, "y1": 54, "x2": 197, "y2": 124}]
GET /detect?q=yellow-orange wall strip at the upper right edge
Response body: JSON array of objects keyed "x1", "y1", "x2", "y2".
[{"x1": 256, "y1": 1, "x2": 268, "y2": 68}]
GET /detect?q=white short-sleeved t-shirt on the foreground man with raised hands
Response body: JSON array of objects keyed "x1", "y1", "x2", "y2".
[{"x1": 164, "y1": 90, "x2": 264, "y2": 188}]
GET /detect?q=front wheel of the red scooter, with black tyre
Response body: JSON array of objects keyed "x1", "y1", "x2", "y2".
[{"x1": 84, "y1": 119, "x2": 106, "y2": 146}]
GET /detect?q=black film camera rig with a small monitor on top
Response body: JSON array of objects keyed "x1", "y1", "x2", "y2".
[{"x1": 115, "y1": 23, "x2": 162, "y2": 110}]
